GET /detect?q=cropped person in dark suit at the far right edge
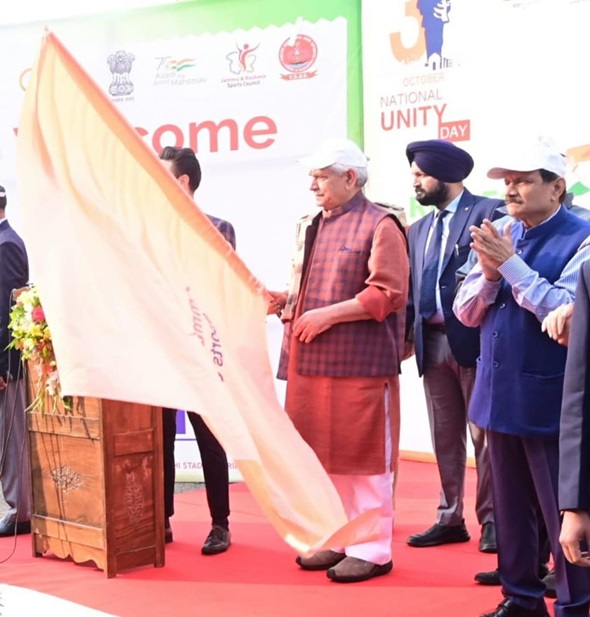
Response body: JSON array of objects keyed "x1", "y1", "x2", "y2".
[{"x1": 543, "y1": 261, "x2": 590, "y2": 567}]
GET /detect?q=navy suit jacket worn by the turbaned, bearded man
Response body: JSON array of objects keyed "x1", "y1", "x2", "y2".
[{"x1": 406, "y1": 189, "x2": 504, "y2": 375}]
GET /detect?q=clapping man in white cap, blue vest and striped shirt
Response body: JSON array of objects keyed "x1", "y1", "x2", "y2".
[{"x1": 454, "y1": 140, "x2": 590, "y2": 617}]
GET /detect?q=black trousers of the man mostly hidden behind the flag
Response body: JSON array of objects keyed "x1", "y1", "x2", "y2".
[{"x1": 162, "y1": 407, "x2": 234, "y2": 529}]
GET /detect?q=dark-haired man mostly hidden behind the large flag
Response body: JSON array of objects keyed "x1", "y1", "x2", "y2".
[{"x1": 160, "y1": 146, "x2": 236, "y2": 555}]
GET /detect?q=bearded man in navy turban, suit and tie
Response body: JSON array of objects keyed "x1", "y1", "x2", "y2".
[{"x1": 406, "y1": 140, "x2": 503, "y2": 552}]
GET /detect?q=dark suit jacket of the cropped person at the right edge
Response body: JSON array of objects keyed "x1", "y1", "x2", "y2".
[{"x1": 559, "y1": 261, "x2": 590, "y2": 510}]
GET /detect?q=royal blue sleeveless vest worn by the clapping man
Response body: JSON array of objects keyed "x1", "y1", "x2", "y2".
[{"x1": 469, "y1": 208, "x2": 590, "y2": 438}]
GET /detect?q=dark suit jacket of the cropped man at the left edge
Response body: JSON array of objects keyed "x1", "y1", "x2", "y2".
[{"x1": 0, "y1": 220, "x2": 29, "y2": 377}]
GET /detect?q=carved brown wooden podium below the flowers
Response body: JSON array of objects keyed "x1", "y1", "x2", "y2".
[{"x1": 27, "y1": 390, "x2": 165, "y2": 578}]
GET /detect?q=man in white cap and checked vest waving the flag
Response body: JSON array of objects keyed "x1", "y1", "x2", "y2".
[{"x1": 274, "y1": 139, "x2": 409, "y2": 583}]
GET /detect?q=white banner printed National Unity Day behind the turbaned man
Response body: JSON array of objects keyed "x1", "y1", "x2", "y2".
[{"x1": 362, "y1": 0, "x2": 590, "y2": 221}]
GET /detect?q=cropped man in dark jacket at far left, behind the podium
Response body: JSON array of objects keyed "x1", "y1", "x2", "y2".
[{"x1": 0, "y1": 186, "x2": 31, "y2": 536}]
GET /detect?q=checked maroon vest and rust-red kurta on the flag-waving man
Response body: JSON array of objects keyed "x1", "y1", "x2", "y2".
[{"x1": 279, "y1": 193, "x2": 409, "y2": 475}]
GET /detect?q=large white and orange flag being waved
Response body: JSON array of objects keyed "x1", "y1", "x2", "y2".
[{"x1": 17, "y1": 33, "x2": 379, "y2": 554}]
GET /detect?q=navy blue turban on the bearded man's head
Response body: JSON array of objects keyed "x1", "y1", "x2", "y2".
[{"x1": 406, "y1": 139, "x2": 473, "y2": 182}]
